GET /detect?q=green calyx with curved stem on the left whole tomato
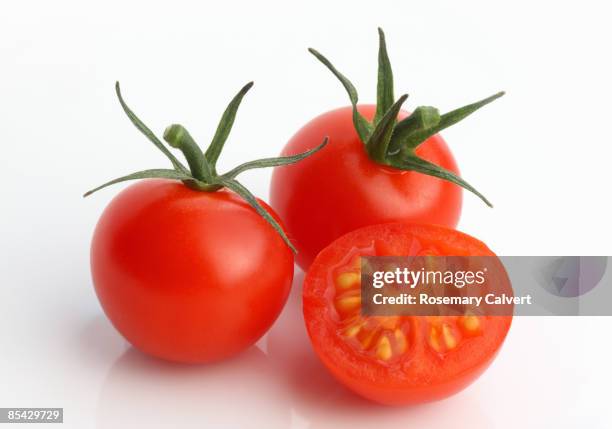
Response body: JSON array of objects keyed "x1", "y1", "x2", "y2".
[{"x1": 83, "y1": 82, "x2": 327, "y2": 252}]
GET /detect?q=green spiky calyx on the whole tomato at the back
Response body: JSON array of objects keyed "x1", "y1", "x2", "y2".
[{"x1": 308, "y1": 28, "x2": 504, "y2": 207}]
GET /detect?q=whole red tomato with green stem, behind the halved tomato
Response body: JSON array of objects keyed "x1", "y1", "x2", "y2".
[{"x1": 270, "y1": 31, "x2": 503, "y2": 269}]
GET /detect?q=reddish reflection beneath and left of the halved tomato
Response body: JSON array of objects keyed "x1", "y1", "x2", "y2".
[{"x1": 266, "y1": 270, "x2": 494, "y2": 429}]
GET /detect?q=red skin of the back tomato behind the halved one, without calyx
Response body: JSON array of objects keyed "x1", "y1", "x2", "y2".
[{"x1": 270, "y1": 105, "x2": 462, "y2": 270}]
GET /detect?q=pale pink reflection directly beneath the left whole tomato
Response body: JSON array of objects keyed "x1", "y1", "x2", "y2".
[{"x1": 96, "y1": 346, "x2": 291, "y2": 429}]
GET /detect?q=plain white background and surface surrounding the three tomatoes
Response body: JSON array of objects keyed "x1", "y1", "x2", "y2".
[{"x1": 0, "y1": 0, "x2": 612, "y2": 429}]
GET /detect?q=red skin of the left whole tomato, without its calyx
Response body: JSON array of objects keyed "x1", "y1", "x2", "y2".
[{"x1": 91, "y1": 180, "x2": 293, "y2": 363}]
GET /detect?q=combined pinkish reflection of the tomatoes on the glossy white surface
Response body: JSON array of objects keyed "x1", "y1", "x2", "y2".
[{"x1": 88, "y1": 273, "x2": 492, "y2": 429}]
